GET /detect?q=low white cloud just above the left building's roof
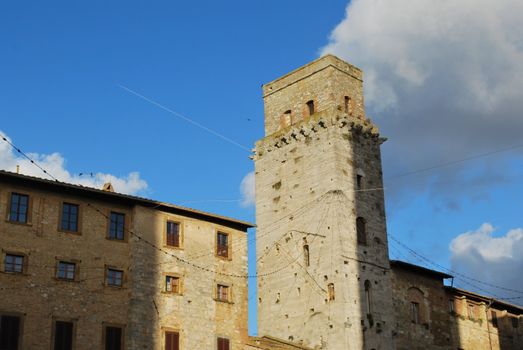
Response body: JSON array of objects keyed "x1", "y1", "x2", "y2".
[{"x1": 0, "y1": 132, "x2": 147, "y2": 194}]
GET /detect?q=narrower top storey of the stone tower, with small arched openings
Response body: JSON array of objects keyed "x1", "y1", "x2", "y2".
[{"x1": 262, "y1": 54, "x2": 365, "y2": 136}]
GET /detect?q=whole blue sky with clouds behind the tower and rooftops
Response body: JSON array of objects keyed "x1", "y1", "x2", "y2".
[{"x1": 0, "y1": 0, "x2": 523, "y2": 330}]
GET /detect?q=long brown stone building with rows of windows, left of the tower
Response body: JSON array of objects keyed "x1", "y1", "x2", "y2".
[{"x1": 0, "y1": 172, "x2": 251, "y2": 350}]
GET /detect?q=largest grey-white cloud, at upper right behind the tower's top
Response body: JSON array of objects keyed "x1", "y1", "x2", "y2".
[{"x1": 321, "y1": 0, "x2": 523, "y2": 208}]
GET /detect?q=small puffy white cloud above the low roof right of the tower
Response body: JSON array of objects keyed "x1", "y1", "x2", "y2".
[{"x1": 450, "y1": 223, "x2": 523, "y2": 297}]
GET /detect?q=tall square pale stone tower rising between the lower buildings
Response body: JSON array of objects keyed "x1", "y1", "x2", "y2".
[{"x1": 254, "y1": 55, "x2": 393, "y2": 350}]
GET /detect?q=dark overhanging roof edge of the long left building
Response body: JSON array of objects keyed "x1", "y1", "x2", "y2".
[{"x1": 0, "y1": 170, "x2": 255, "y2": 231}]
